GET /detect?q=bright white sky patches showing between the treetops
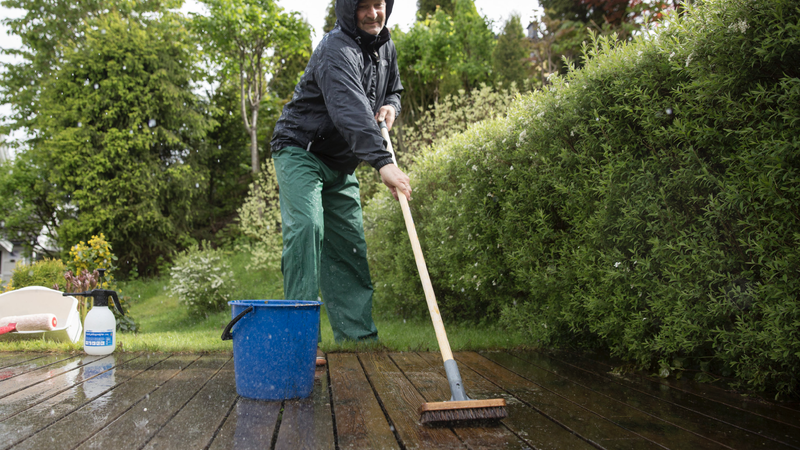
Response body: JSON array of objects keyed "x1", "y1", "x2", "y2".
[{"x1": 0, "y1": 0, "x2": 541, "y2": 142}]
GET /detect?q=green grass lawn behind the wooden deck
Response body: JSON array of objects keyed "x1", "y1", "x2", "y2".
[{"x1": 0, "y1": 248, "x2": 526, "y2": 352}]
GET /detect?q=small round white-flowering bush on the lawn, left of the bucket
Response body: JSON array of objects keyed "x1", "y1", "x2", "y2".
[{"x1": 169, "y1": 241, "x2": 233, "y2": 315}]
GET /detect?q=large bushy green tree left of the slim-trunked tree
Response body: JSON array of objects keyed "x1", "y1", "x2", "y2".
[{"x1": 34, "y1": 12, "x2": 212, "y2": 274}]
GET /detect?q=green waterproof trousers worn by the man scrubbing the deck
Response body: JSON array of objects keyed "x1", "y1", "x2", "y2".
[{"x1": 272, "y1": 147, "x2": 378, "y2": 342}]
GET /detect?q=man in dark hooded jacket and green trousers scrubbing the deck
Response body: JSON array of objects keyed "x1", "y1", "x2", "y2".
[{"x1": 271, "y1": 0, "x2": 411, "y2": 342}]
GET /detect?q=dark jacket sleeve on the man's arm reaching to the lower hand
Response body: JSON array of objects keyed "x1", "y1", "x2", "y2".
[{"x1": 314, "y1": 47, "x2": 392, "y2": 169}]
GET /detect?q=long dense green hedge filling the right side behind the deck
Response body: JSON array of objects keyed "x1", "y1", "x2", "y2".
[{"x1": 365, "y1": 0, "x2": 800, "y2": 395}]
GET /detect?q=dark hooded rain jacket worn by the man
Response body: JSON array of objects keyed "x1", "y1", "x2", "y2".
[{"x1": 271, "y1": 0, "x2": 403, "y2": 173}]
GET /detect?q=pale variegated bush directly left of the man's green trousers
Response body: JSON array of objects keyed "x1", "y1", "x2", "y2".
[{"x1": 238, "y1": 159, "x2": 283, "y2": 270}]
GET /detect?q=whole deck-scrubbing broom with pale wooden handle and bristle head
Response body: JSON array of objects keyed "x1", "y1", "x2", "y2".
[{"x1": 380, "y1": 122, "x2": 508, "y2": 424}]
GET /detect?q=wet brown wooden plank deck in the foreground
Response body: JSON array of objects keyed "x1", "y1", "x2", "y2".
[{"x1": 0, "y1": 352, "x2": 800, "y2": 450}]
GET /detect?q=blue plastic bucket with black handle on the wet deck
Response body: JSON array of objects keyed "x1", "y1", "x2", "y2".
[{"x1": 222, "y1": 300, "x2": 322, "y2": 400}]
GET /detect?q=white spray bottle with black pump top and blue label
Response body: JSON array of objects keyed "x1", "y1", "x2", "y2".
[{"x1": 63, "y1": 269, "x2": 125, "y2": 355}]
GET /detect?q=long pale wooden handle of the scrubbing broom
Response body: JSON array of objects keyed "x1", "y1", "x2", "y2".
[{"x1": 381, "y1": 122, "x2": 453, "y2": 361}]
